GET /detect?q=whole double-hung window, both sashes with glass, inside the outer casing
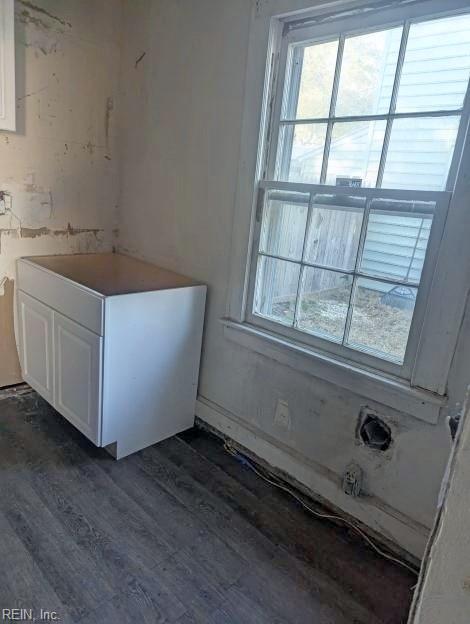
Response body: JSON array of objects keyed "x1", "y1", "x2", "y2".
[{"x1": 248, "y1": 4, "x2": 470, "y2": 377}]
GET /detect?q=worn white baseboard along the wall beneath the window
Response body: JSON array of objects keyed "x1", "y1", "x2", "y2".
[{"x1": 196, "y1": 396, "x2": 430, "y2": 559}]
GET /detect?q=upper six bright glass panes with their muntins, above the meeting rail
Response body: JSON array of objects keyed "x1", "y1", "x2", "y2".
[{"x1": 274, "y1": 14, "x2": 470, "y2": 190}]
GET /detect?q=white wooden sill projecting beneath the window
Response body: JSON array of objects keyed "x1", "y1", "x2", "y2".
[{"x1": 221, "y1": 318, "x2": 447, "y2": 424}]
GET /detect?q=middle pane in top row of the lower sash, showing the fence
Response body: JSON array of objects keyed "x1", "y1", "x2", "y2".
[{"x1": 305, "y1": 195, "x2": 366, "y2": 271}]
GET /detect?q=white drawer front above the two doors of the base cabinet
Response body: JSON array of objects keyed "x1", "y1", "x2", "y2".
[{"x1": 18, "y1": 260, "x2": 104, "y2": 336}]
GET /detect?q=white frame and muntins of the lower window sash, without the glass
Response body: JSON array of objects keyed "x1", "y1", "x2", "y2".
[{"x1": 246, "y1": 181, "x2": 452, "y2": 379}]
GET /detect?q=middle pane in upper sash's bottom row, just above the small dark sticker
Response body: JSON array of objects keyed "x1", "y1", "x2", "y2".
[{"x1": 326, "y1": 121, "x2": 386, "y2": 187}]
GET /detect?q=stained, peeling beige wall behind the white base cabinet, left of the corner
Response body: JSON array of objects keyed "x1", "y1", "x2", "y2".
[{"x1": 0, "y1": 0, "x2": 122, "y2": 386}]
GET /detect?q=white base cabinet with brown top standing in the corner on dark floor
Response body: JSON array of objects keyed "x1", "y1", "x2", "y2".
[{"x1": 17, "y1": 254, "x2": 206, "y2": 459}]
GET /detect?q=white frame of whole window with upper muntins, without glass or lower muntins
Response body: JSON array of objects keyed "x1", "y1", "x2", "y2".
[{"x1": 244, "y1": 0, "x2": 470, "y2": 381}]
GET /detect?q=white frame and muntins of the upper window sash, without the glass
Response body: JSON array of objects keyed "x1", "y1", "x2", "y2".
[{"x1": 263, "y1": 0, "x2": 470, "y2": 191}]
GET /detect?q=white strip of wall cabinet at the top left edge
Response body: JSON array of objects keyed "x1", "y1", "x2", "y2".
[{"x1": 0, "y1": 0, "x2": 16, "y2": 131}]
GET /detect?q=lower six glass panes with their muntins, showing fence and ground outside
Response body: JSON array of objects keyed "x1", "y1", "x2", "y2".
[{"x1": 253, "y1": 187, "x2": 436, "y2": 364}]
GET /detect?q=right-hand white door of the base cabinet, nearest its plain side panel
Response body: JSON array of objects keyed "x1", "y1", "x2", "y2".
[{"x1": 54, "y1": 312, "x2": 102, "y2": 446}]
